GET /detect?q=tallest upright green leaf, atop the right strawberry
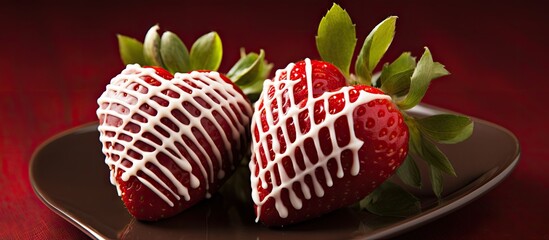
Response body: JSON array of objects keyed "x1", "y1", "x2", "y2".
[{"x1": 316, "y1": 3, "x2": 356, "y2": 77}]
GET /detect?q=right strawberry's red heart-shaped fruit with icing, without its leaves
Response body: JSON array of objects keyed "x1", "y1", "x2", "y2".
[{"x1": 250, "y1": 60, "x2": 408, "y2": 226}]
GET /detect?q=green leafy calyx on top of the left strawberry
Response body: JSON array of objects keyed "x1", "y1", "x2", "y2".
[{"x1": 117, "y1": 25, "x2": 273, "y2": 102}]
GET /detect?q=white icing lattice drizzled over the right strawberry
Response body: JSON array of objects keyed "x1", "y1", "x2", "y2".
[{"x1": 249, "y1": 59, "x2": 390, "y2": 222}]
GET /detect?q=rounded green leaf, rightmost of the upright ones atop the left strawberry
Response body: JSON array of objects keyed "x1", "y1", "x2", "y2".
[{"x1": 190, "y1": 32, "x2": 223, "y2": 71}]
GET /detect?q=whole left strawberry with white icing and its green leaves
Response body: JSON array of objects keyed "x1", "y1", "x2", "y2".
[{"x1": 97, "y1": 26, "x2": 271, "y2": 221}]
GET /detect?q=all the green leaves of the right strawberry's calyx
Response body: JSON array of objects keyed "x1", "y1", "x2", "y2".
[{"x1": 316, "y1": 4, "x2": 474, "y2": 216}]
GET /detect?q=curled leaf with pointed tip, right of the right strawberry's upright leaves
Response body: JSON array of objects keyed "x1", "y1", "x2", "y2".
[{"x1": 397, "y1": 48, "x2": 450, "y2": 110}]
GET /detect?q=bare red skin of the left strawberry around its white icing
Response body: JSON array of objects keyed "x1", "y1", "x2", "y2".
[{"x1": 99, "y1": 67, "x2": 251, "y2": 221}]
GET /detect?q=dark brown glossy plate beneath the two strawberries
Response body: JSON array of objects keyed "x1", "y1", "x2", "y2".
[{"x1": 30, "y1": 105, "x2": 520, "y2": 240}]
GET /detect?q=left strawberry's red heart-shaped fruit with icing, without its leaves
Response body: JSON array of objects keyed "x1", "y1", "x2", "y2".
[{"x1": 97, "y1": 65, "x2": 252, "y2": 220}]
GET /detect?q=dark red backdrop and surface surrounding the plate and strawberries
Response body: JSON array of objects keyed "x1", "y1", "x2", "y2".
[{"x1": 0, "y1": 0, "x2": 549, "y2": 239}]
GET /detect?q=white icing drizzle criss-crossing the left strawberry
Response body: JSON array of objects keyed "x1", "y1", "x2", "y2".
[{"x1": 97, "y1": 64, "x2": 252, "y2": 207}]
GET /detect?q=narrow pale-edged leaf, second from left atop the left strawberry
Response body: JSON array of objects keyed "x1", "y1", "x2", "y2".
[{"x1": 160, "y1": 32, "x2": 191, "y2": 74}]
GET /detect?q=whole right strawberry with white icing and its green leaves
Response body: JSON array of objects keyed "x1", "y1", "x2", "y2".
[{"x1": 249, "y1": 4, "x2": 472, "y2": 226}]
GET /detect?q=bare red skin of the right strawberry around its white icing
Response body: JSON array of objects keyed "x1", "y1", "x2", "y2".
[{"x1": 252, "y1": 60, "x2": 408, "y2": 226}]
